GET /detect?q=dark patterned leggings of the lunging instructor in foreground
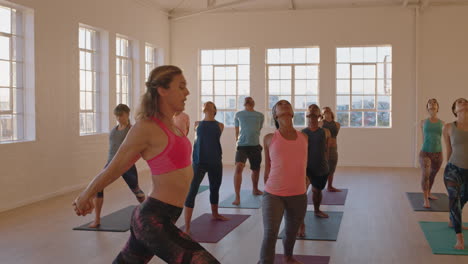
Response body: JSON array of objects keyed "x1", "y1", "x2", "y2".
[{"x1": 113, "y1": 197, "x2": 220, "y2": 264}]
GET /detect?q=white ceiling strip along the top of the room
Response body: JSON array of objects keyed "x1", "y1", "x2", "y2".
[{"x1": 146, "y1": 0, "x2": 468, "y2": 18}]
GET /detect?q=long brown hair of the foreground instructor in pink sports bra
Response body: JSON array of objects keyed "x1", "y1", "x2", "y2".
[{"x1": 137, "y1": 65, "x2": 182, "y2": 120}]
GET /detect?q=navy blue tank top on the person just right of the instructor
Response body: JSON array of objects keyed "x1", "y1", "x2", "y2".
[{"x1": 193, "y1": 121, "x2": 223, "y2": 164}]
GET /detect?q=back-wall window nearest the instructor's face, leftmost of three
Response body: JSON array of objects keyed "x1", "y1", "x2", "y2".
[{"x1": 200, "y1": 49, "x2": 250, "y2": 126}]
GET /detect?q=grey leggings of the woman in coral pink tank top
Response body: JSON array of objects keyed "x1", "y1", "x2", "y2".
[{"x1": 259, "y1": 192, "x2": 307, "y2": 264}]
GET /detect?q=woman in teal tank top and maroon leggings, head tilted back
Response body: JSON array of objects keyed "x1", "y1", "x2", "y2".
[{"x1": 419, "y1": 98, "x2": 444, "y2": 208}]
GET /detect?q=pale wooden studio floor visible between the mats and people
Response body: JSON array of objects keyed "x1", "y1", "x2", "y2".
[{"x1": 0, "y1": 167, "x2": 468, "y2": 264}]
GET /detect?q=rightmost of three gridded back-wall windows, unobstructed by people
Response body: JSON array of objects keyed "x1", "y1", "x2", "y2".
[{"x1": 336, "y1": 46, "x2": 392, "y2": 127}]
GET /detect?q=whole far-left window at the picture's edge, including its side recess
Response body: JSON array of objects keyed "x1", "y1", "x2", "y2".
[{"x1": 0, "y1": 5, "x2": 35, "y2": 143}]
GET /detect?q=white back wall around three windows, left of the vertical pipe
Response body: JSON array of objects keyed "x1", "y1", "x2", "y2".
[{"x1": 171, "y1": 8, "x2": 416, "y2": 167}]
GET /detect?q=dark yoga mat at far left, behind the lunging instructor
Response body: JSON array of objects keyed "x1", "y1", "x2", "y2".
[{"x1": 73, "y1": 205, "x2": 136, "y2": 232}]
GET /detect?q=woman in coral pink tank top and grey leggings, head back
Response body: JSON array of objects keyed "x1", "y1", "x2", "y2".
[{"x1": 260, "y1": 100, "x2": 308, "y2": 264}]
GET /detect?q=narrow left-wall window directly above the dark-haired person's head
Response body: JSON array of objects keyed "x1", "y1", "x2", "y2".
[{"x1": 115, "y1": 36, "x2": 133, "y2": 108}]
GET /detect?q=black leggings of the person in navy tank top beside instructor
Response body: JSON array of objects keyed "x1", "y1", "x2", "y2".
[{"x1": 185, "y1": 162, "x2": 223, "y2": 208}]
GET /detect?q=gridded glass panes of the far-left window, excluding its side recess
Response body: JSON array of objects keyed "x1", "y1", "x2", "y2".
[{"x1": 0, "y1": 5, "x2": 25, "y2": 143}]
